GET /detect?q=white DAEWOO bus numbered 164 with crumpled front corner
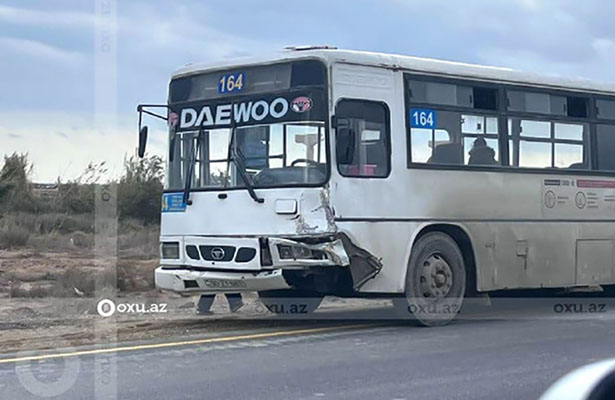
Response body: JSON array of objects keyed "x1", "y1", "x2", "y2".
[{"x1": 138, "y1": 47, "x2": 615, "y2": 325}]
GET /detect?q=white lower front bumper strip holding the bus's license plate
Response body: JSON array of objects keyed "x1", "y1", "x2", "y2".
[{"x1": 155, "y1": 267, "x2": 290, "y2": 294}]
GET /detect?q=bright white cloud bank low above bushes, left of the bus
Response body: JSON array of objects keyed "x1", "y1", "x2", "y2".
[{"x1": 0, "y1": 110, "x2": 166, "y2": 182}]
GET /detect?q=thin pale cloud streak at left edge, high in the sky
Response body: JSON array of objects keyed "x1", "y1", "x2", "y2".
[{"x1": 0, "y1": 36, "x2": 86, "y2": 67}]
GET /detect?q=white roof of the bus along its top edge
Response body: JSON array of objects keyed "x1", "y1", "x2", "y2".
[{"x1": 173, "y1": 46, "x2": 615, "y2": 95}]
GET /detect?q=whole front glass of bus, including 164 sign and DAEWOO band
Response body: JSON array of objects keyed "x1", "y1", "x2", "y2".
[{"x1": 166, "y1": 60, "x2": 329, "y2": 191}]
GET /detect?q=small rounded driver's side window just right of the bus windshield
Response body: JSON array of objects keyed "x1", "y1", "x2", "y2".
[{"x1": 336, "y1": 100, "x2": 391, "y2": 178}]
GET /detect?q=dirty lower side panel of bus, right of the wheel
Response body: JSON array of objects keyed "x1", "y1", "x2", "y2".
[{"x1": 466, "y1": 221, "x2": 615, "y2": 291}]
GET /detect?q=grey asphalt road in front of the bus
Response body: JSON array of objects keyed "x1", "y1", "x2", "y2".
[{"x1": 0, "y1": 302, "x2": 615, "y2": 400}]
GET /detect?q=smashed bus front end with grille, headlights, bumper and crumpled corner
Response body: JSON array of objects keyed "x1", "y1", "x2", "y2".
[{"x1": 155, "y1": 234, "x2": 382, "y2": 294}]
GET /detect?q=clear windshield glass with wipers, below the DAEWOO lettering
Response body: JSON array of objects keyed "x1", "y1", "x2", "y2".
[{"x1": 167, "y1": 121, "x2": 327, "y2": 190}]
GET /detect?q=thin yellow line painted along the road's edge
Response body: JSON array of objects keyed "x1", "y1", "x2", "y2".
[{"x1": 0, "y1": 324, "x2": 373, "y2": 364}]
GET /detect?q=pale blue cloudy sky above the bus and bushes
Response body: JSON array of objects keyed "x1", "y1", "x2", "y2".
[{"x1": 0, "y1": 0, "x2": 615, "y2": 182}]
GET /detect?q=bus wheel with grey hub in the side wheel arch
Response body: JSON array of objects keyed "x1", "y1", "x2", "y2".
[{"x1": 393, "y1": 232, "x2": 467, "y2": 326}]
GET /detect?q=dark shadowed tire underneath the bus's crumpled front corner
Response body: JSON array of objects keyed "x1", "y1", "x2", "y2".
[{"x1": 258, "y1": 290, "x2": 323, "y2": 315}]
